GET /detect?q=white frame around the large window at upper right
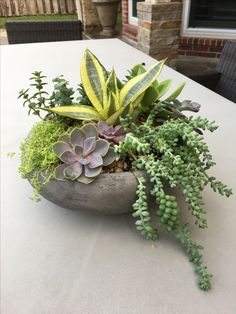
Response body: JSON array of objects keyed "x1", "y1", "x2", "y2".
[{"x1": 181, "y1": 0, "x2": 236, "y2": 39}]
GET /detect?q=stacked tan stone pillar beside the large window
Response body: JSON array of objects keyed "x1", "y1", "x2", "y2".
[{"x1": 137, "y1": 0, "x2": 182, "y2": 59}]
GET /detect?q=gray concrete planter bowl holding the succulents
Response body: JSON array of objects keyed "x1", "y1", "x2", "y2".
[{"x1": 29, "y1": 172, "x2": 151, "y2": 215}]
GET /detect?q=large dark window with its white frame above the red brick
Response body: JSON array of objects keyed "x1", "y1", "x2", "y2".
[{"x1": 181, "y1": 0, "x2": 236, "y2": 39}]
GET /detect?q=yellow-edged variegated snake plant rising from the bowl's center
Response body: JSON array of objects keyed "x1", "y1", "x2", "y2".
[{"x1": 48, "y1": 49, "x2": 165, "y2": 125}]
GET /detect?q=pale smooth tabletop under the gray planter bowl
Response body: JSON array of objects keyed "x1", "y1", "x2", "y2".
[{"x1": 1, "y1": 39, "x2": 236, "y2": 314}]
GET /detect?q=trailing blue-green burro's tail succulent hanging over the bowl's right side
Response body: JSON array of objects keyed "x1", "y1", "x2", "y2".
[{"x1": 116, "y1": 109, "x2": 232, "y2": 290}]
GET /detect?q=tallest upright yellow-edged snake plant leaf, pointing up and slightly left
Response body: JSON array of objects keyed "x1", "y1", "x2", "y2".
[{"x1": 81, "y1": 49, "x2": 106, "y2": 116}]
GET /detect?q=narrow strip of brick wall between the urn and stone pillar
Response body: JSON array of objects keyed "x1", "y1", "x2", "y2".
[{"x1": 122, "y1": 0, "x2": 138, "y2": 44}]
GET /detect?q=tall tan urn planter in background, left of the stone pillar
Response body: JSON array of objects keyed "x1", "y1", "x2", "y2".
[{"x1": 92, "y1": 0, "x2": 120, "y2": 37}]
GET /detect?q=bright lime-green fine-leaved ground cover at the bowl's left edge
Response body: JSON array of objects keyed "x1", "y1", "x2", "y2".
[{"x1": 19, "y1": 120, "x2": 78, "y2": 201}]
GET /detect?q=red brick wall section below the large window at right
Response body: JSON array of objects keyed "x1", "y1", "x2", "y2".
[{"x1": 178, "y1": 37, "x2": 225, "y2": 58}]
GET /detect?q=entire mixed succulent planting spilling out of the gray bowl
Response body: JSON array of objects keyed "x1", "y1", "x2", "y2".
[{"x1": 19, "y1": 50, "x2": 232, "y2": 290}]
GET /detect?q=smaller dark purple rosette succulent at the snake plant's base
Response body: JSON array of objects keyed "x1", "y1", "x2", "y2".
[{"x1": 97, "y1": 121, "x2": 125, "y2": 144}]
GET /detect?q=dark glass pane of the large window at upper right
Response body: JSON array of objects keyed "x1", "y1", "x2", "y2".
[{"x1": 189, "y1": 0, "x2": 236, "y2": 29}]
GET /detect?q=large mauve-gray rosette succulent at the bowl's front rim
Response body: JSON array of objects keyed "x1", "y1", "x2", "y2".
[{"x1": 53, "y1": 123, "x2": 118, "y2": 184}]
